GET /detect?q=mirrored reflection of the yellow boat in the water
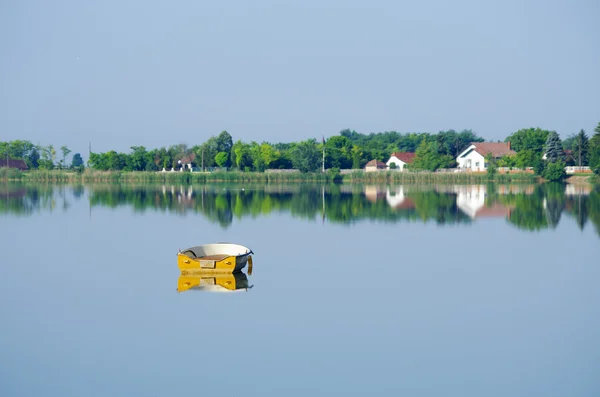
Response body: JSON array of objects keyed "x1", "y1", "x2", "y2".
[{"x1": 177, "y1": 272, "x2": 252, "y2": 292}]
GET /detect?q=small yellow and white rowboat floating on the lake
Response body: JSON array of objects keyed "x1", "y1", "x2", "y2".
[{"x1": 177, "y1": 243, "x2": 254, "y2": 273}]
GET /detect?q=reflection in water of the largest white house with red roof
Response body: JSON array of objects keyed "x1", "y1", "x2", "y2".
[{"x1": 454, "y1": 185, "x2": 511, "y2": 219}]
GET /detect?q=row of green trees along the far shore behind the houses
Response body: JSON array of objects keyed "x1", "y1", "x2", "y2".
[{"x1": 0, "y1": 123, "x2": 600, "y2": 175}]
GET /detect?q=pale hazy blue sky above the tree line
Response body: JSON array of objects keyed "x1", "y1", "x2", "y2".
[{"x1": 0, "y1": 0, "x2": 600, "y2": 157}]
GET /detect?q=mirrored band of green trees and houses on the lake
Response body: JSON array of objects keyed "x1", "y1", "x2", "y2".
[{"x1": 0, "y1": 184, "x2": 600, "y2": 234}]
